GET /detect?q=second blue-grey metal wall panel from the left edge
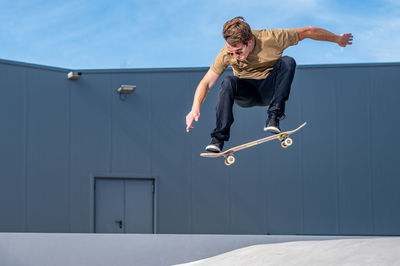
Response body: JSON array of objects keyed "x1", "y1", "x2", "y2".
[{"x1": 24, "y1": 69, "x2": 70, "y2": 232}]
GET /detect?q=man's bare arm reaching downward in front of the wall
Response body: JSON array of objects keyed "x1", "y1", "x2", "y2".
[{"x1": 186, "y1": 69, "x2": 219, "y2": 132}]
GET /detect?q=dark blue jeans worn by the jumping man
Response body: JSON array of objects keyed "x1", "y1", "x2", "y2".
[{"x1": 211, "y1": 56, "x2": 296, "y2": 141}]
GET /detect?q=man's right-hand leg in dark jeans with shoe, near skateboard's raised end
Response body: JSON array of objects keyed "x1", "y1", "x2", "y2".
[{"x1": 264, "y1": 56, "x2": 296, "y2": 133}]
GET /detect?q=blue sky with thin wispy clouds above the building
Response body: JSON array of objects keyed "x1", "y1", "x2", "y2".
[{"x1": 0, "y1": 0, "x2": 400, "y2": 69}]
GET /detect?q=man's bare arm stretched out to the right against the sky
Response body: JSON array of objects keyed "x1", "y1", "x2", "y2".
[{"x1": 296, "y1": 27, "x2": 353, "y2": 47}]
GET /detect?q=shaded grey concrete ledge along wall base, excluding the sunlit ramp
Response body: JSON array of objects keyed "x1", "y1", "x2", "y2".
[{"x1": 0, "y1": 233, "x2": 390, "y2": 266}]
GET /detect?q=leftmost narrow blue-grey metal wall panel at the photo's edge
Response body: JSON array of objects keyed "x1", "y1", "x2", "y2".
[{"x1": 0, "y1": 64, "x2": 26, "y2": 232}]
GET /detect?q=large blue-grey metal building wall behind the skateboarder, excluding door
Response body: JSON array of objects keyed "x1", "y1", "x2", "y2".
[{"x1": 0, "y1": 60, "x2": 400, "y2": 235}]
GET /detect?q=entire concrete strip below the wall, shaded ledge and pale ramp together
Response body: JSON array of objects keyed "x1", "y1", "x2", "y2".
[{"x1": 0, "y1": 233, "x2": 400, "y2": 266}]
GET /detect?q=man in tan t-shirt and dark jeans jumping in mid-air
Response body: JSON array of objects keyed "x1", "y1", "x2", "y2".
[{"x1": 186, "y1": 17, "x2": 353, "y2": 152}]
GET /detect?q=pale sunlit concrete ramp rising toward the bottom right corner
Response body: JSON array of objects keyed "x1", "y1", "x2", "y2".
[{"x1": 179, "y1": 237, "x2": 400, "y2": 266}]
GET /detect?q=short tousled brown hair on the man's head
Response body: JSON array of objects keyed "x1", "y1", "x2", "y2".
[{"x1": 222, "y1": 17, "x2": 253, "y2": 46}]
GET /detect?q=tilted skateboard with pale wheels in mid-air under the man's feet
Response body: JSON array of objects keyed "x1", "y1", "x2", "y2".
[{"x1": 200, "y1": 122, "x2": 307, "y2": 166}]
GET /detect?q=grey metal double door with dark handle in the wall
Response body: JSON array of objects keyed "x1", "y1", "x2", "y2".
[{"x1": 95, "y1": 179, "x2": 154, "y2": 234}]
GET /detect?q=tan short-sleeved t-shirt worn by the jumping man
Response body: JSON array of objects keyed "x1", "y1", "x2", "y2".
[{"x1": 211, "y1": 29, "x2": 299, "y2": 79}]
